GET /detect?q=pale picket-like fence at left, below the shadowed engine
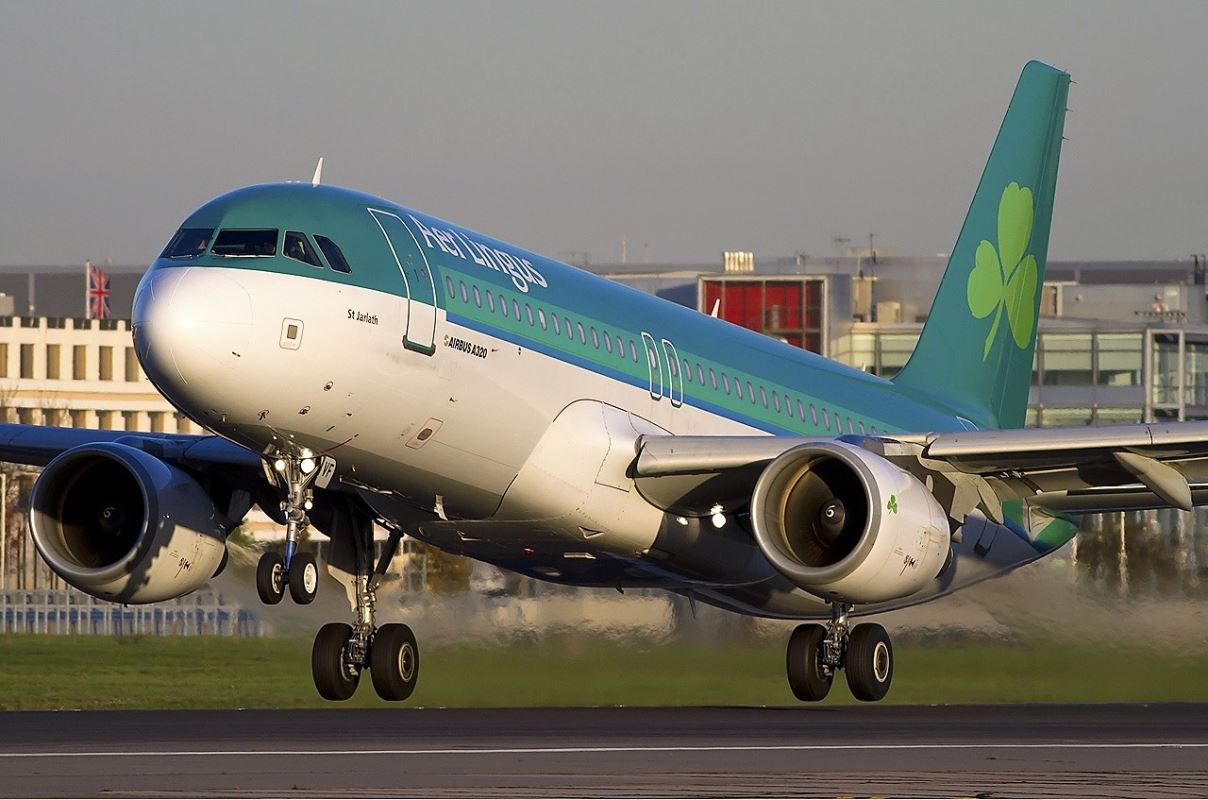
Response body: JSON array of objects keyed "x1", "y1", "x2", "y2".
[{"x1": 0, "y1": 589, "x2": 262, "y2": 637}]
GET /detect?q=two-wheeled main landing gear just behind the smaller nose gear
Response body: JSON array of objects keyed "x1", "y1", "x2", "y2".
[{"x1": 310, "y1": 505, "x2": 419, "y2": 700}]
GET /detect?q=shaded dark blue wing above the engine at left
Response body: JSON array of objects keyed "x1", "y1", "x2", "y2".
[{"x1": 0, "y1": 424, "x2": 262, "y2": 473}]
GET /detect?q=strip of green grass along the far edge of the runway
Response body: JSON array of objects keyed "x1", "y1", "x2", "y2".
[{"x1": 0, "y1": 636, "x2": 1208, "y2": 709}]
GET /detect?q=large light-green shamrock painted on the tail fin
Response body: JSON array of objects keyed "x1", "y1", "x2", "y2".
[{"x1": 969, "y1": 181, "x2": 1038, "y2": 361}]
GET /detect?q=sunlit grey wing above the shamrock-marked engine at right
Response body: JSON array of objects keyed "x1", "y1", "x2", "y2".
[{"x1": 633, "y1": 422, "x2": 1208, "y2": 514}]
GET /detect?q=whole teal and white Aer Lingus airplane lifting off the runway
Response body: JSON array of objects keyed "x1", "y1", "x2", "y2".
[{"x1": 0, "y1": 62, "x2": 1208, "y2": 701}]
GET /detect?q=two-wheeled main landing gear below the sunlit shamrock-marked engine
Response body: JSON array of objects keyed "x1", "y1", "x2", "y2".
[{"x1": 786, "y1": 603, "x2": 894, "y2": 702}]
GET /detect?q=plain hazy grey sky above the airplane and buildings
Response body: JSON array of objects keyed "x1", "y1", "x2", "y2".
[{"x1": 0, "y1": 0, "x2": 1208, "y2": 265}]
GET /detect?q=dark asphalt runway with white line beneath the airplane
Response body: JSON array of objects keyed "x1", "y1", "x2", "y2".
[{"x1": 0, "y1": 705, "x2": 1208, "y2": 796}]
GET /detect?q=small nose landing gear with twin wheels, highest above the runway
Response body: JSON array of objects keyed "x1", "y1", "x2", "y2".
[{"x1": 256, "y1": 456, "x2": 319, "y2": 605}]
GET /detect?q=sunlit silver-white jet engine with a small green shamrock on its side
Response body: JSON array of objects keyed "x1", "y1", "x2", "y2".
[{"x1": 751, "y1": 441, "x2": 951, "y2": 603}]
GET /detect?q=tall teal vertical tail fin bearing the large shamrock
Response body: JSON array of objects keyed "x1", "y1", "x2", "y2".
[{"x1": 894, "y1": 62, "x2": 1069, "y2": 428}]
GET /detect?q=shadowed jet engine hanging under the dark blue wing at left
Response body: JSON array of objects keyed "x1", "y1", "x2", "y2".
[{"x1": 29, "y1": 442, "x2": 230, "y2": 603}]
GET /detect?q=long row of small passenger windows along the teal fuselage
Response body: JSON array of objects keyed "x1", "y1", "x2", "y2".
[{"x1": 445, "y1": 277, "x2": 877, "y2": 435}]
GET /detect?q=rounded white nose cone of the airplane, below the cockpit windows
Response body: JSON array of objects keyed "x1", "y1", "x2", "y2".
[{"x1": 132, "y1": 267, "x2": 252, "y2": 407}]
